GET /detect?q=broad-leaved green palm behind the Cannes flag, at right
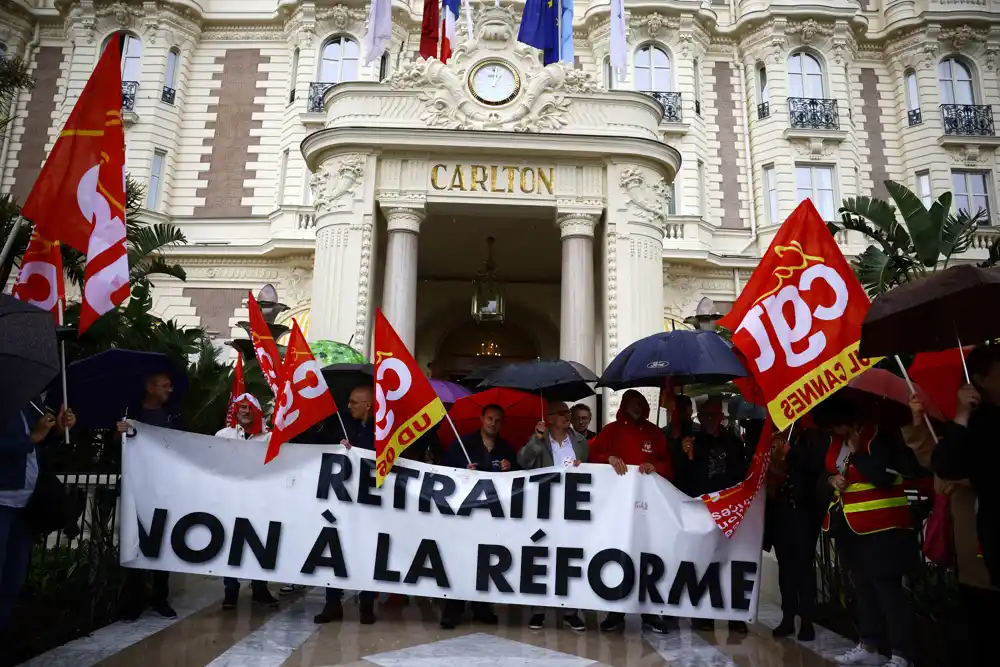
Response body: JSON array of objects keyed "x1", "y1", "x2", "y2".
[{"x1": 828, "y1": 181, "x2": 1000, "y2": 297}]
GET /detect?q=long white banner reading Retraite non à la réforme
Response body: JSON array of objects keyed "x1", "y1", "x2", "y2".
[{"x1": 120, "y1": 424, "x2": 764, "y2": 621}]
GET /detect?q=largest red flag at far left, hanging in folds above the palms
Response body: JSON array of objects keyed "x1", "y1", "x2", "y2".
[{"x1": 21, "y1": 33, "x2": 129, "y2": 333}]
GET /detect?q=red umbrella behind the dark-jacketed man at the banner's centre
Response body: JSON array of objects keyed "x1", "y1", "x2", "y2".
[{"x1": 438, "y1": 387, "x2": 546, "y2": 449}]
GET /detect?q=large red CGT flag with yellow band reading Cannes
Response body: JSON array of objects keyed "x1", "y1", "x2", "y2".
[{"x1": 719, "y1": 199, "x2": 879, "y2": 431}]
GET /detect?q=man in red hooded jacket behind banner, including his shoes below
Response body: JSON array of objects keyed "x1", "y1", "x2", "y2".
[{"x1": 590, "y1": 389, "x2": 674, "y2": 635}]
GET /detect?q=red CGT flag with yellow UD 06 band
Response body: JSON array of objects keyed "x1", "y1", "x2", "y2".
[{"x1": 375, "y1": 308, "x2": 445, "y2": 487}]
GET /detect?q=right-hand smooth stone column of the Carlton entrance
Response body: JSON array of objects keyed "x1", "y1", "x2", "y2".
[{"x1": 556, "y1": 212, "x2": 600, "y2": 372}]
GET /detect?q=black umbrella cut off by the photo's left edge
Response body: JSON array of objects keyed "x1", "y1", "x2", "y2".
[{"x1": 0, "y1": 294, "x2": 59, "y2": 424}]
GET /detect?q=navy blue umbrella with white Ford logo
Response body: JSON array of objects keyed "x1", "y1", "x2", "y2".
[{"x1": 600, "y1": 331, "x2": 746, "y2": 391}]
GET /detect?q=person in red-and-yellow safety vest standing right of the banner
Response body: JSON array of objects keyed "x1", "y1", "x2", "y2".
[{"x1": 813, "y1": 397, "x2": 918, "y2": 667}]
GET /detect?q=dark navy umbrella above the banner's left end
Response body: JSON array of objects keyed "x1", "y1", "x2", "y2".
[{"x1": 46, "y1": 348, "x2": 187, "y2": 428}]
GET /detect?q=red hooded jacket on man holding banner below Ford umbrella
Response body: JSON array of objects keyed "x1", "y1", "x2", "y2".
[{"x1": 590, "y1": 389, "x2": 674, "y2": 480}]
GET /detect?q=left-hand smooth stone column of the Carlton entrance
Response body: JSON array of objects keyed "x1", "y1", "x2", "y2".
[{"x1": 382, "y1": 207, "x2": 424, "y2": 352}]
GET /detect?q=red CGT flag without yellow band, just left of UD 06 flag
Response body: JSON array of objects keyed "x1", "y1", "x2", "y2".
[{"x1": 264, "y1": 321, "x2": 337, "y2": 463}]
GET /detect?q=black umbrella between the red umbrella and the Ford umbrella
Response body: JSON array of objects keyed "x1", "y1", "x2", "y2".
[{"x1": 479, "y1": 359, "x2": 597, "y2": 402}]
